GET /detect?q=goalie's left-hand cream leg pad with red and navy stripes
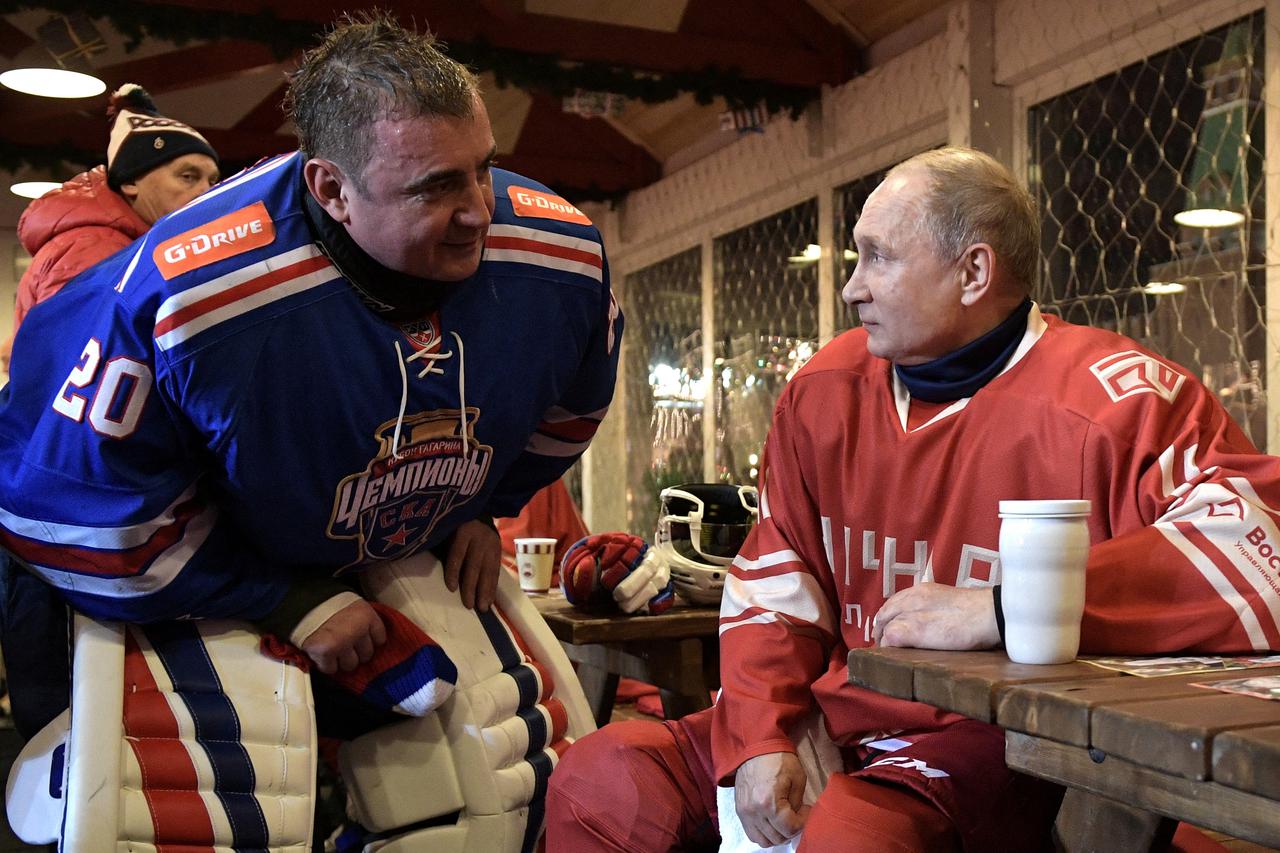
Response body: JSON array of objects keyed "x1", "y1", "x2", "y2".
[{"x1": 8, "y1": 616, "x2": 316, "y2": 853}]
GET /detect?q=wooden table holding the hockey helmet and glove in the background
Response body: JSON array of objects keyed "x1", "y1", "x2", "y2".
[{"x1": 530, "y1": 590, "x2": 719, "y2": 726}]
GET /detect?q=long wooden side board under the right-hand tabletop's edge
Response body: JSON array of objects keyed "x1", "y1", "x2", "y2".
[{"x1": 1005, "y1": 727, "x2": 1280, "y2": 847}]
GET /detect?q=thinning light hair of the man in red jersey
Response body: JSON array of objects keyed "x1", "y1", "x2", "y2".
[{"x1": 890, "y1": 147, "x2": 1039, "y2": 292}]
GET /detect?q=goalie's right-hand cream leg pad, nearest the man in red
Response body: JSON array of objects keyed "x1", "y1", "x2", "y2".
[{"x1": 342, "y1": 555, "x2": 595, "y2": 853}]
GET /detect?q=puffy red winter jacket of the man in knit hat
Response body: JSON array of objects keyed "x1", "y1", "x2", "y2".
[{"x1": 13, "y1": 167, "x2": 147, "y2": 332}]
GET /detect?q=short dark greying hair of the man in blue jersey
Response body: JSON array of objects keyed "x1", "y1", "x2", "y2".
[{"x1": 284, "y1": 12, "x2": 480, "y2": 186}]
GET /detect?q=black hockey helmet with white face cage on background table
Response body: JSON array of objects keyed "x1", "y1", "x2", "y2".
[{"x1": 654, "y1": 483, "x2": 759, "y2": 605}]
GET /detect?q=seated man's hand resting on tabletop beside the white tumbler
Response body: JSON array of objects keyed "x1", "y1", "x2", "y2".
[{"x1": 872, "y1": 583, "x2": 1000, "y2": 649}]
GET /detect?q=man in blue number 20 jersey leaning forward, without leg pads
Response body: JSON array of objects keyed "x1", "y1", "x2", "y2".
[{"x1": 0, "y1": 15, "x2": 622, "y2": 732}]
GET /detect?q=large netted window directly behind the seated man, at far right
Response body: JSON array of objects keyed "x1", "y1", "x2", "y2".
[{"x1": 1027, "y1": 13, "x2": 1268, "y2": 446}]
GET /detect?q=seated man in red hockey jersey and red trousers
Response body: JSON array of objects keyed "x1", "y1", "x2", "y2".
[{"x1": 548, "y1": 149, "x2": 1280, "y2": 853}]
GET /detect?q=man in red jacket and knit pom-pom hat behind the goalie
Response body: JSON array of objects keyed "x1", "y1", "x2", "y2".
[{"x1": 0, "y1": 83, "x2": 219, "y2": 370}]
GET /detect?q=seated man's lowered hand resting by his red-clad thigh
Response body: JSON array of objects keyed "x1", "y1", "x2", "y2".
[{"x1": 733, "y1": 752, "x2": 809, "y2": 847}]
